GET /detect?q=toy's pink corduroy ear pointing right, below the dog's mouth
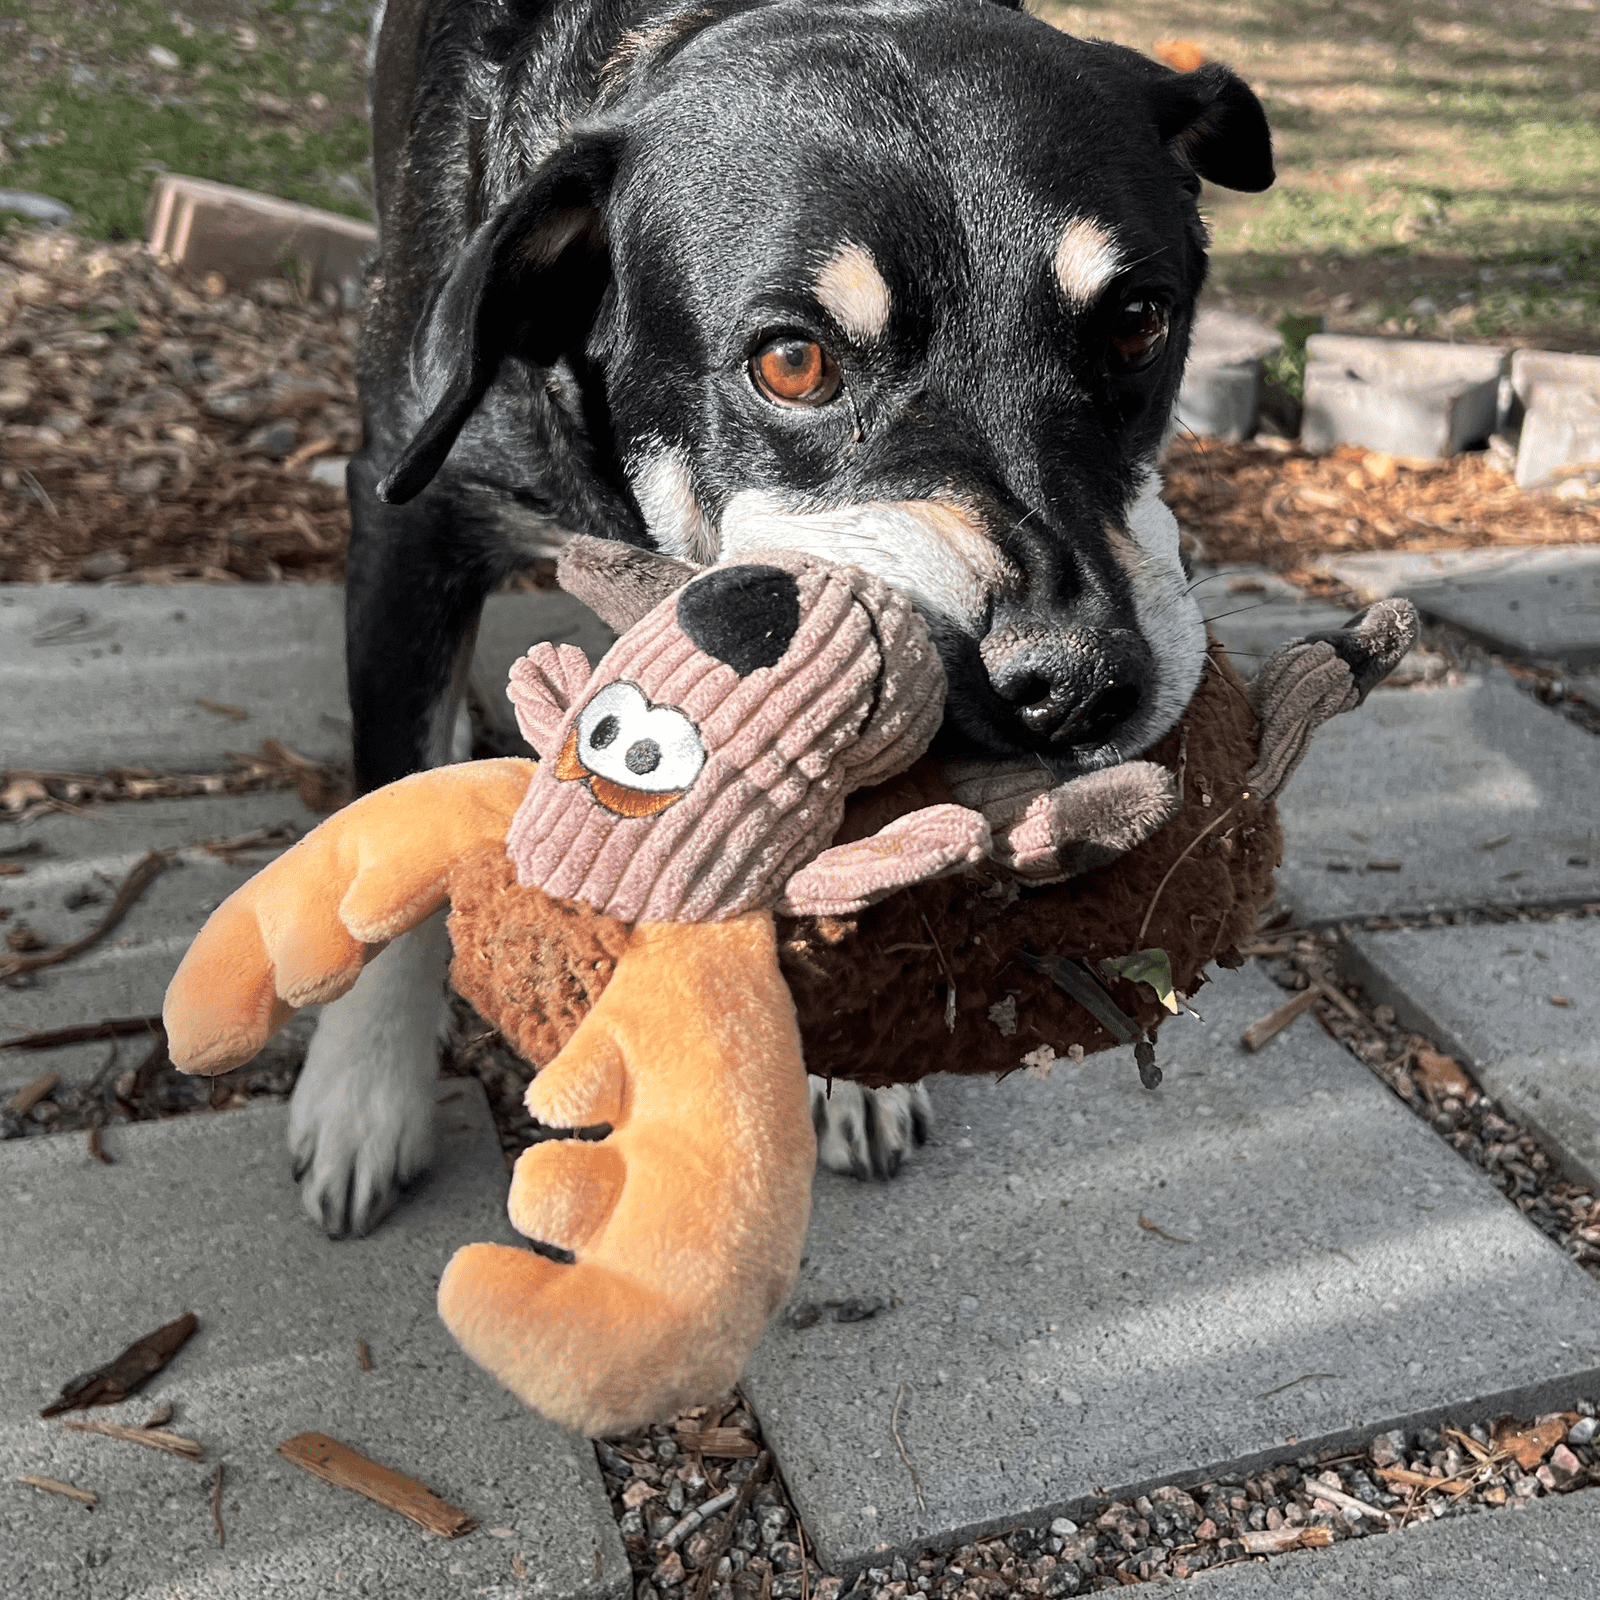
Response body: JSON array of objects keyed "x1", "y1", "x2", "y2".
[{"x1": 778, "y1": 805, "x2": 990, "y2": 917}]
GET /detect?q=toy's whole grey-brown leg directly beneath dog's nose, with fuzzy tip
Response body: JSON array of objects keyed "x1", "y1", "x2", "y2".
[{"x1": 944, "y1": 762, "x2": 1179, "y2": 883}]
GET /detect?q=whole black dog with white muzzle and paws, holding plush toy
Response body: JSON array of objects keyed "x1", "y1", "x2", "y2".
[{"x1": 290, "y1": 0, "x2": 1272, "y2": 1234}]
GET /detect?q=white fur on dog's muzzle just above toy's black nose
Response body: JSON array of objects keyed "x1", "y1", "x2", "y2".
[{"x1": 720, "y1": 490, "x2": 1013, "y2": 629}]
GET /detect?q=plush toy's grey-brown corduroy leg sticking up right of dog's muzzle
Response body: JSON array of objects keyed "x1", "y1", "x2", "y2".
[{"x1": 1245, "y1": 600, "x2": 1418, "y2": 800}]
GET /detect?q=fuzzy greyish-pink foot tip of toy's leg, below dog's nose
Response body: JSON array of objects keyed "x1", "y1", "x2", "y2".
[{"x1": 995, "y1": 762, "x2": 1179, "y2": 882}]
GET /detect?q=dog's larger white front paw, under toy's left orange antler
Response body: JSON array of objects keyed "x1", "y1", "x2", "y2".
[{"x1": 290, "y1": 914, "x2": 450, "y2": 1238}]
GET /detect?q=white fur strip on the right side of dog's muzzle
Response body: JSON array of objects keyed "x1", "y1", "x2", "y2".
[{"x1": 1112, "y1": 472, "x2": 1205, "y2": 758}]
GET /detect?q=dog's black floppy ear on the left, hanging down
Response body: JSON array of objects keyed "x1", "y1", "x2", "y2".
[{"x1": 378, "y1": 133, "x2": 621, "y2": 506}]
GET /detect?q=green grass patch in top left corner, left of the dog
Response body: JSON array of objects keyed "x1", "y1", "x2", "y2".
[{"x1": 0, "y1": 0, "x2": 370, "y2": 238}]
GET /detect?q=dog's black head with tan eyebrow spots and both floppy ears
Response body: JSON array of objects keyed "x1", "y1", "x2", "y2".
[{"x1": 386, "y1": 0, "x2": 1272, "y2": 776}]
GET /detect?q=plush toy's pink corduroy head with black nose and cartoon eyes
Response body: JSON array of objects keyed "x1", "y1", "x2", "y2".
[{"x1": 507, "y1": 552, "x2": 944, "y2": 922}]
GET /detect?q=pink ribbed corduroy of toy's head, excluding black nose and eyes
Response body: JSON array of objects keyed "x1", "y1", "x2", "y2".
[{"x1": 507, "y1": 552, "x2": 944, "y2": 922}]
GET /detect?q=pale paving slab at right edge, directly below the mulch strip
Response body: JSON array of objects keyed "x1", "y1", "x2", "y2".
[{"x1": 1318, "y1": 544, "x2": 1600, "y2": 667}]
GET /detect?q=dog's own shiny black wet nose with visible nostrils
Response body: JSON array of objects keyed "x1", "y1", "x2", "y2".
[{"x1": 981, "y1": 627, "x2": 1152, "y2": 750}]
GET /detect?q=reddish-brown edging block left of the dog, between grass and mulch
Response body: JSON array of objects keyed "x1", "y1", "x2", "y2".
[{"x1": 144, "y1": 173, "x2": 378, "y2": 293}]
